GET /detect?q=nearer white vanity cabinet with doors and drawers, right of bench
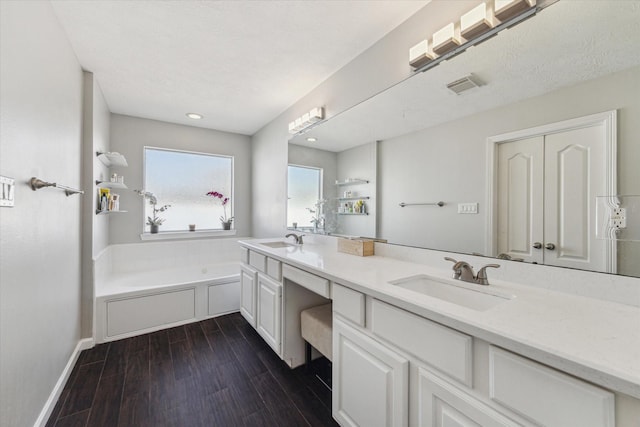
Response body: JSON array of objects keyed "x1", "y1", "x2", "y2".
[{"x1": 333, "y1": 298, "x2": 616, "y2": 427}]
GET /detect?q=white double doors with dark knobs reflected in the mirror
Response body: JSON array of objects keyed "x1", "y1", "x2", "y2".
[{"x1": 496, "y1": 113, "x2": 615, "y2": 272}]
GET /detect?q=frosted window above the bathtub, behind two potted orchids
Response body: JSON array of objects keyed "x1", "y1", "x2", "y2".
[{"x1": 144, "y1": 147, "x2": 233, "y2": 232}]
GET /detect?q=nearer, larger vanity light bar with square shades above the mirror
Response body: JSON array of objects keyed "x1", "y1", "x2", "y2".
[{"x1": 409, "y1": 0, "x2": 536, "y2": 72}]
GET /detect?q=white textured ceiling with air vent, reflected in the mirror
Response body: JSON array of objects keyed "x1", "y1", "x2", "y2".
[{"x1": 292, "y1": 0, "x2": 640, "y2": 151}]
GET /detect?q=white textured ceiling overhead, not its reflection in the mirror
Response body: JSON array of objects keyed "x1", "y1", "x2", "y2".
[{"x1": 52, "y1": 0, "x2": 429, "y2": 135}]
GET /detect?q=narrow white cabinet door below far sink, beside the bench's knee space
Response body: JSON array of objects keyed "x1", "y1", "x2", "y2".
[{"x1": 256, "y1": 273, "x2": 282, "y2": 355}]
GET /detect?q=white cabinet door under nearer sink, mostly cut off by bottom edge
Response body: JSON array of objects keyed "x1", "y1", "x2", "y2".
[{"x1": 417, "y1": 368, "x2": 523, "y2": 427}]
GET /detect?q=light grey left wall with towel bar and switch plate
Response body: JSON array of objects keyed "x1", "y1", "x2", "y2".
[{"x1": 0, "y1": 1, "x2": 84, "y2": 426}]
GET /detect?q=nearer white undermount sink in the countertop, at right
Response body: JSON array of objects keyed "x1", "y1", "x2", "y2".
[{"x1": 389, "y1": 274, "x2": 515, "y2": 311}]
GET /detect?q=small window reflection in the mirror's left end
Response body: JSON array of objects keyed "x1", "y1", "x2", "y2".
[{"x1": 287, "y1": 165, "x2": 322, "y2": 228}]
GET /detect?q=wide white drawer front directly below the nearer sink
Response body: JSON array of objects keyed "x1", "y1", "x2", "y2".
[{"x1": 371, "y1": 300, "x2": 472, "y2": 387}]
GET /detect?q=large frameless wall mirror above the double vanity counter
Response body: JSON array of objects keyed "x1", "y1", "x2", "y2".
[{"x1": 289, "y1": 0, "x2": 640, "y2": 277}]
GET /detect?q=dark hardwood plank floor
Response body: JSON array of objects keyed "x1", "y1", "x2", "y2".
[{"x1": 47, "y1": 314, "x2": 337, "y2": 427}]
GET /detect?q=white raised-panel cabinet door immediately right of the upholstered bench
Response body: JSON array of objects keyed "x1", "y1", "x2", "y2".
[{"x1": 333, "y1": 316, "x2": 409, "y2": 427}]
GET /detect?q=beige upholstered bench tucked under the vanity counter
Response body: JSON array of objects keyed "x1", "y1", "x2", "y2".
[{"x1": 300, "y1": 303, "x2": 333, "y2": 364}]
